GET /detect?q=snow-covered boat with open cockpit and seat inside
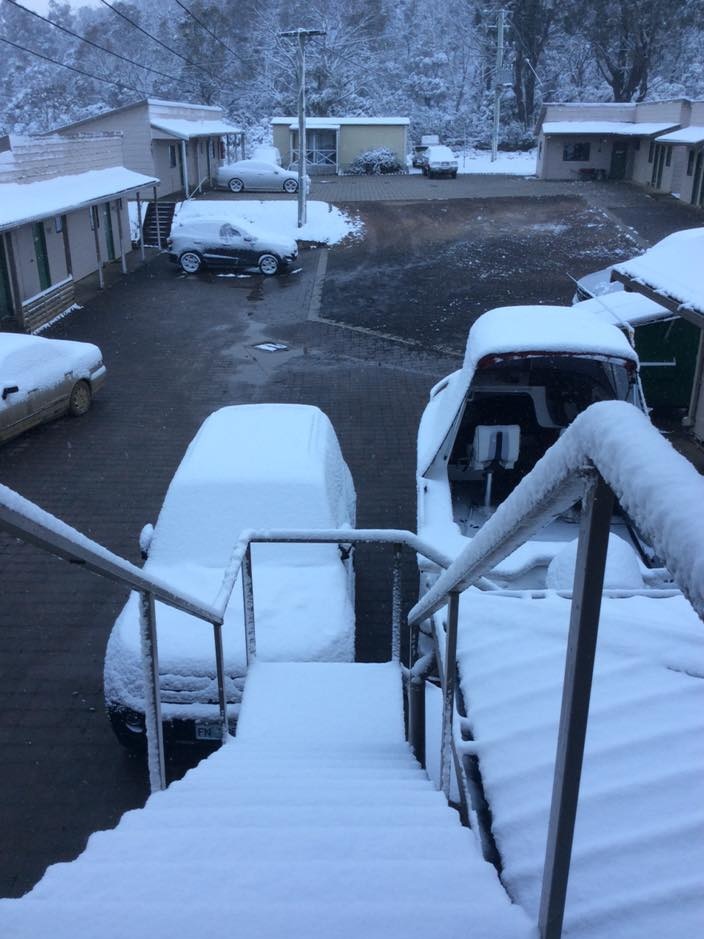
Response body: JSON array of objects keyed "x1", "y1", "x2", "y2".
[{"x1": 417, "y1": 306, "x2": 643, "y2": 590}]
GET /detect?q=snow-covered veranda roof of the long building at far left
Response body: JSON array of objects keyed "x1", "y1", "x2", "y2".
[{"x1": 0, "y1": 166, "x2": 159, "y2": 231}]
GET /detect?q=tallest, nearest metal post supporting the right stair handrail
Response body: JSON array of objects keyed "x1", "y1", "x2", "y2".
[{"x1": 538, "y1": 470, "x2": 614, "y2": 939}]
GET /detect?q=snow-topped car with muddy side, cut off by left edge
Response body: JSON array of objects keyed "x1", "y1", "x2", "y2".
[{"x1": 0, "y1": 333, "x2": 106, "y2": 442}]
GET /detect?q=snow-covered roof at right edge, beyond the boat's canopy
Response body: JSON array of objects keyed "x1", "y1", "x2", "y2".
[{"x1": 614, "y1": 228, "x2": 704, "y2": 317}]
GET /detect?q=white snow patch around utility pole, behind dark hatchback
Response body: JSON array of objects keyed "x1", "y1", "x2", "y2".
[{"x1": 170, "y1": 199, "x2": 364, "y2": 245}]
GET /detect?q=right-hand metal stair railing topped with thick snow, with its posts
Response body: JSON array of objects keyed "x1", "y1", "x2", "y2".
[{"x1": 408, "y1": 402, "x2": 704, "y2": 939}]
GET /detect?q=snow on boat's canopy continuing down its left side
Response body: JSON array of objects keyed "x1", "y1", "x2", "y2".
[{"x1": 418, "y1": 304, "x2": 638, "y2": 475}]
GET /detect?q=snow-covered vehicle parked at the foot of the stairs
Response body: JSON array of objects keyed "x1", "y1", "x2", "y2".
[{"x1": 104, "y1": 404, "x2": 356, "y2": 747}]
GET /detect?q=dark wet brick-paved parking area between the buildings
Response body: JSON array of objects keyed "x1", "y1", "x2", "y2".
[{"x1": 0, "y1": 177, "x2": 700, "y2": 896}]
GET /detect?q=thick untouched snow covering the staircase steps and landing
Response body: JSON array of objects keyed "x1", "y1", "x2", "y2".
[{"x1": 0, "y1": 663, "x2": 534, "y2": 939}]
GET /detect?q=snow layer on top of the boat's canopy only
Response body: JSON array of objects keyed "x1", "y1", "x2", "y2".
[{"x1": 464, "y1": 306, "x2": 638, "y2": 371}]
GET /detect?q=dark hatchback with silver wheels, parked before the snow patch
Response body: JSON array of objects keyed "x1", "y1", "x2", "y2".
[{"x1": 166, "y1": 215, "x2": 298, "y2": 276}]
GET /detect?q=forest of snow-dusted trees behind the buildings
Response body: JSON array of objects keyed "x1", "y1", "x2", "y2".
[{"x1": 0, "y1": 0, "x2": 704, "y2": 147}]
